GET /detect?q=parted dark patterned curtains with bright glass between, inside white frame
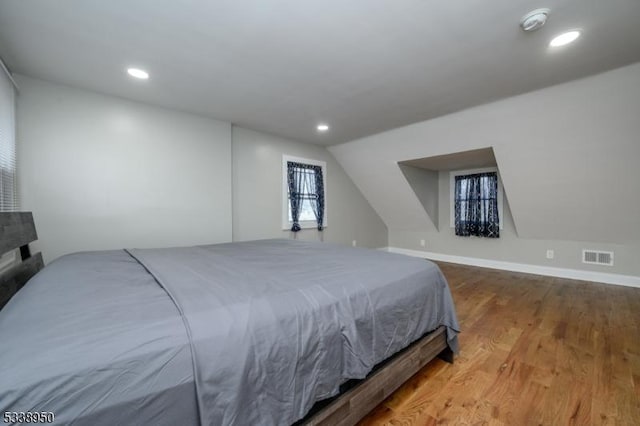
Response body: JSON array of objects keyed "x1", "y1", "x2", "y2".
[{"x1": 287, "y1": 161, "x2": 324, "y2": 232}]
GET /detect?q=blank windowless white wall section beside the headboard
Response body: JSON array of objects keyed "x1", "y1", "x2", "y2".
[{"x1": 17, "y1": 76, "x2": 232, "y2": 261}]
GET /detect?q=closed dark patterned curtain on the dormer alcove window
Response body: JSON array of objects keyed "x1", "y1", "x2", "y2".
[{"x1": 455, "y1": 172, "x2": 500, "y2": 238}]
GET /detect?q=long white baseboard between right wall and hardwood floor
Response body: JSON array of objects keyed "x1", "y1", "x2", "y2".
[{"x1": 380, "y1": 247, "x2": 640, "y2": 288}]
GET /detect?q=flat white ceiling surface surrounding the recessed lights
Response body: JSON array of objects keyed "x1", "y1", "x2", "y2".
[{"x1": 0, "y1": 0, "x2": 640, "y2": 145}]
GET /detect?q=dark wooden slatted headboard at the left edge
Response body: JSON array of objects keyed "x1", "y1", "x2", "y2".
[{"x1": 0, "y1": 212, "x2": 44, "y2": 309}]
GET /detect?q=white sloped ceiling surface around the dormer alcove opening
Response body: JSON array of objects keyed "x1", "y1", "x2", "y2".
[{"x1": 329, "y1": 64, "x2": 640, "y2": 243}]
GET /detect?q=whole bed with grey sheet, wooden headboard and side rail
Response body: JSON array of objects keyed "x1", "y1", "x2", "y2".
[{"x1": 0, "y1": 213, "x2": 458, "y2": 425}]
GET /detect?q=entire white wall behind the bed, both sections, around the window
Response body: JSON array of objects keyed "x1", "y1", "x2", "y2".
[{"x1": 17, "y1": 76, "x2": 388, "y2": 262}]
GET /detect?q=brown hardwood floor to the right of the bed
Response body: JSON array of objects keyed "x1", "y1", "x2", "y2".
[{"x1": 361, "y1": 263, "x2": 640, "y2": 425}]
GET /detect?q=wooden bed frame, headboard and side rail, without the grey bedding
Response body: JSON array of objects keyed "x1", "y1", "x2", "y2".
[{"x1": 0, "y1": 212, "x2": 453, "y2": 426}]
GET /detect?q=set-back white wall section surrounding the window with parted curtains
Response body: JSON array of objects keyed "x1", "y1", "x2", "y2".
[{"x1": 233, "y1": 127, "x2": 387, "y2": 248}]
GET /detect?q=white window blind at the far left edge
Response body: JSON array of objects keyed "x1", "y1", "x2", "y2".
[{"x1": 0, "y1": 60, "x2": 18, "y2": 212}]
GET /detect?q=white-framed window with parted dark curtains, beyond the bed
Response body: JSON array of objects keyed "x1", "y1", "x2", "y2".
[{"x1": 282, "y1": 155, "x2": 327, "y2": 232}]
